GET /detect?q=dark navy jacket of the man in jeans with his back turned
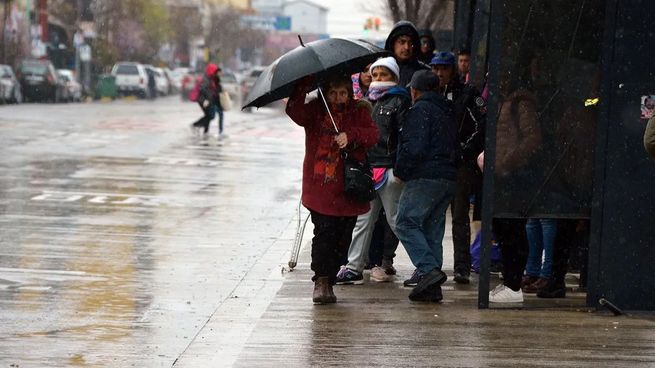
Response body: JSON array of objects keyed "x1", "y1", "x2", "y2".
[{"x1": 394, "y1": 92, "x2": 457, "y2": 181}]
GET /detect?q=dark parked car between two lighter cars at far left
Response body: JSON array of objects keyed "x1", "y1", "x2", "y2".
[{"x1": 18, "y1": 60, "x2": 66, "y2": 102}]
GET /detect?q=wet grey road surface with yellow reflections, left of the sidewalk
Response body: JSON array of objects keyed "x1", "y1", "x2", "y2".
[{"x1": 0, "y1": 97, "x2": 303, "y2": 367}]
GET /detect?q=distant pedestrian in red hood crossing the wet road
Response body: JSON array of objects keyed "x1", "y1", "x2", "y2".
[{"x1": 192, "y1": 63, "x2": 223, "y2": 136}]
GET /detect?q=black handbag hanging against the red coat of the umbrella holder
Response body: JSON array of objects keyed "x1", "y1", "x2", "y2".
[{"x1": 342, "y1": 152, "x2": 376, "y2": 202}]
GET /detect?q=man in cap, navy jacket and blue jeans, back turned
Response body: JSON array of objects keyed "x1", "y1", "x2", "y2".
[{"x1": 394, "y1": 70, "x2": 458, "y2": 302}]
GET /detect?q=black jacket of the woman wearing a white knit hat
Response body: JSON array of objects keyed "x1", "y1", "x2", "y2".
[{"x1": 368, "y1": 87, "x2": 412, "y2": 167}]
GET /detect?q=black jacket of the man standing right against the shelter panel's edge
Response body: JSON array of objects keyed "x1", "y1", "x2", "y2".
[{"x1": 443, "y1": 78, "x2": 485, "y2": 163}]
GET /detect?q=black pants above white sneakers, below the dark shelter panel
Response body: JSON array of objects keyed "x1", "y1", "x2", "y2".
[{"x1": 493, "y1": 218, "x2": 528, "y2": 291}]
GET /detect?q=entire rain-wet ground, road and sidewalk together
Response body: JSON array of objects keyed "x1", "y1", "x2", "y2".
[{"x1": 0, "y1": 97, "x2": 655, "y2": 367}]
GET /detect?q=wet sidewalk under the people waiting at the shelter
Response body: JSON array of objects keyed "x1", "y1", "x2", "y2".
[{"x1": 182, "y1": 214, "x2": 655, "y2": 367}]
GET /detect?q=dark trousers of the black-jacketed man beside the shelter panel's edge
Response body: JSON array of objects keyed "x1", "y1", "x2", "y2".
[{"x1": 450, "y1": 164, "x2": 479, "y2": 273}]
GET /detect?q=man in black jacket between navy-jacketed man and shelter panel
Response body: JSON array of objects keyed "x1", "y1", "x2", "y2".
[{"x1": 404, "y1": 52, "x2": 484, "y2": 286}]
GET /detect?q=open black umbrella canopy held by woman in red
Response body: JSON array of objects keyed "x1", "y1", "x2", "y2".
[{"x1": 243, "y1": 38, "x2": 389, "y2": 109}]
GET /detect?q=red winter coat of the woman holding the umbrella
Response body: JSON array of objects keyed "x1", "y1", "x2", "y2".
[{"x1": 286, "y1": 89, "x2": 379, "y2": 216}]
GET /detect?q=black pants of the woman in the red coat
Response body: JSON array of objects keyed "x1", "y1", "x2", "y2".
[{"x1": 310, "y1": 210, "x2": 357, "y2": 284}]
